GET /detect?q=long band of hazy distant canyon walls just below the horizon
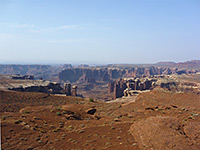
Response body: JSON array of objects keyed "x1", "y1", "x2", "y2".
[{"x1": 0, "y1": 64, "x2": 197, "y2": 83}]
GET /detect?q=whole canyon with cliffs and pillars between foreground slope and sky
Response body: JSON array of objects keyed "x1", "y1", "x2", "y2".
[{"x1": 0, "y1": 60, "x2": 200, "y2": 100}]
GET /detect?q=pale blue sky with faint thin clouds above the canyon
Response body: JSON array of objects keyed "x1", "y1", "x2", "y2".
[{"x1": 0, "y1": 0, "x2": 200, "y2": 64}]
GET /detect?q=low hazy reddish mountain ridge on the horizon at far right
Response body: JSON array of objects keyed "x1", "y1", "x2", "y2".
[{"x1": 156, "y1": 60, "x2": 200, "y2": 69}]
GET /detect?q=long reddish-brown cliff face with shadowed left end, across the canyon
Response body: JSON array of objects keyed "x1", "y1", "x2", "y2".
[{"x1": 58, "y1": 67, "x2": 195, "y2": 82}]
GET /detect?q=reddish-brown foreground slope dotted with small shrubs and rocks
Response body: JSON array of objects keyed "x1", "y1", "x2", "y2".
[{"x1": 0, "y1": 89, "x2": 200, "y2": 150}]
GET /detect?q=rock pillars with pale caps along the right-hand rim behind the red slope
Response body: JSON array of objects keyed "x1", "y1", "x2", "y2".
[{"x1": 108, "y1": 75, "x2": 200, "y2": 99}]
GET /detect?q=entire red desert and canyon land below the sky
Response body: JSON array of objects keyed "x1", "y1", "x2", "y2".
[{"x1": 0, "y1": 61, "x2": 200, "y2": 150}]
